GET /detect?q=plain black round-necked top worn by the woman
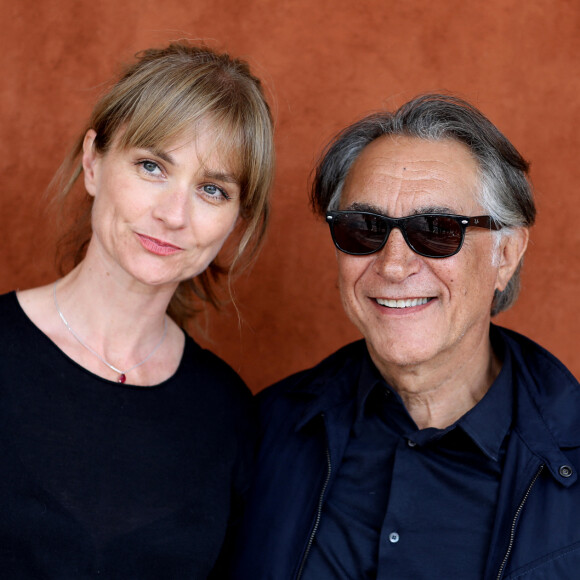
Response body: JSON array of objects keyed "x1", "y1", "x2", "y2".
[{"x1": 0, "y1": 293, "x2": 252, "y2": 580}]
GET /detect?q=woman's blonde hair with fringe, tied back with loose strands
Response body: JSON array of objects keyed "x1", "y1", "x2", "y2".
[{"x1": 53, "y1": 42, "x2": 274, "y2": 324}]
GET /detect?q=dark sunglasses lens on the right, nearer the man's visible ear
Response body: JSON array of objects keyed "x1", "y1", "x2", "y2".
[{"x1": 405, "y1": 216, "x2": 462, "y2": 258}]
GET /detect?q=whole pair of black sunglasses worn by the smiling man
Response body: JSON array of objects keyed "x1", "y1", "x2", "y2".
[{"x1": 326, "y1": 211, "x2": 502, "y2": 258}]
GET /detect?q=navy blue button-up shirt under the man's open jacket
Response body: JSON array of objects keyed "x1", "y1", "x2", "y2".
[{"x1": 303, "y1": 340, "x2": 513, "y2": 580}]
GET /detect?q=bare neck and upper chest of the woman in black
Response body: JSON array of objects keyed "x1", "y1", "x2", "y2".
[{"x1": 18, "y1": 262, "x2": 185, "y2": 385}]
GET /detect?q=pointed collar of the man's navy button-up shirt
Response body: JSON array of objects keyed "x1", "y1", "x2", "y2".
[{"x1": 356, "y1": 337, "x2": 513, "y2": 461}]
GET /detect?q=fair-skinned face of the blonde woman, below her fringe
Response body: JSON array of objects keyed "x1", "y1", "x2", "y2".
[{"x1": 83, "y1": 129, "x2": 240, "y2": 287}]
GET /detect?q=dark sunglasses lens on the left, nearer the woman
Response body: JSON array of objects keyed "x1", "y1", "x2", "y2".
[{"x1": 332, "y1": 213, "x2": 387, "y2": 254}]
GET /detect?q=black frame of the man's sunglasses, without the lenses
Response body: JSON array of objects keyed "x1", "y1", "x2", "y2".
[{"x1": 326, "y1": 210, "x2": 502, "y2": 259}]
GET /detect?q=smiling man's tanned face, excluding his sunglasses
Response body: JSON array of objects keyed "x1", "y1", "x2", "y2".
[{"x1": 337, "y1": 137, "x2": 509, "y2": 369}]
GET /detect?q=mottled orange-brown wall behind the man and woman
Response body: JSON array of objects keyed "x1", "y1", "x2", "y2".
[{"x1": 0, "y1": 0, "x2": 580, "y2": 391}]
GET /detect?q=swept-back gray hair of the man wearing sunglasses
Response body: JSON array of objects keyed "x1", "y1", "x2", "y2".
[{"x1": 311, "y1": 94, "x2": 536, "y2": 316}]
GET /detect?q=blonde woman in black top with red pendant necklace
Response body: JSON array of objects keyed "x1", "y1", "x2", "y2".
[{"x1": 0, "y1": 44, "x2": 273, "y2": 580}]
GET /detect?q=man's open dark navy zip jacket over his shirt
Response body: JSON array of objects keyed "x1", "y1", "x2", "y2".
[{"x1": 231, "y1": 326, "x2": 580, "y2": 580}]
